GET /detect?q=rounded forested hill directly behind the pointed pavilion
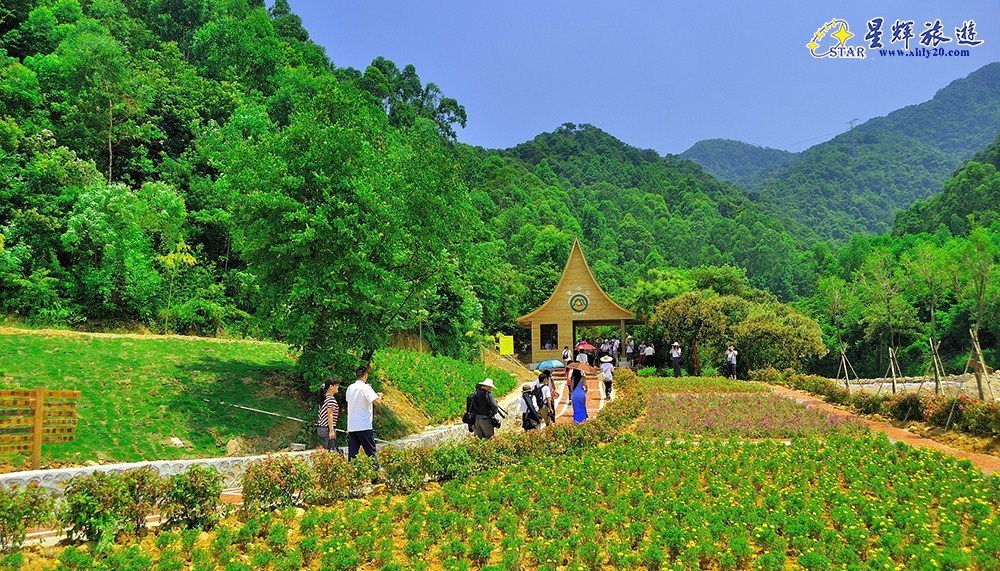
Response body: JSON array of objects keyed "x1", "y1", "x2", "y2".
[{"x1": 478, "y1": 123, "x2": 810, "y2": 303}]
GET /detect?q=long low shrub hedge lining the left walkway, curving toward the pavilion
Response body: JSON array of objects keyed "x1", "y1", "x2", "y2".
[{"x1": 0, "y1": 370, "x2": 652, "y2": 549}]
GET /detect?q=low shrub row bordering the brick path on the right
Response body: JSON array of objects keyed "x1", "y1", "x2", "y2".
[{"x1": 751, "y1": 368, "x2": 1000, "y2": 437}]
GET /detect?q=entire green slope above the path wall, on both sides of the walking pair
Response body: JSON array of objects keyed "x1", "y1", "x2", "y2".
[{"x1": 0, "y1": 328, "x2": 517, "y2": 470}]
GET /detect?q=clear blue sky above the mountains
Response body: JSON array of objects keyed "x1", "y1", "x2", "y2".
[{"x1": 291, "y1": 0, "x2": 1000, "y2": 153}]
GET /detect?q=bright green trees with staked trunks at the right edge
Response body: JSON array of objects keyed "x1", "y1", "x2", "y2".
[{"x1": 796, "y1": 219, "x2": 1000, "y2": 377}]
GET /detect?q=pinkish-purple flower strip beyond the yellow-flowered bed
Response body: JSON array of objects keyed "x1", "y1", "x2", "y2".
[{"x1": 637, "y1": 393, "x2": 868, "y2": 438}]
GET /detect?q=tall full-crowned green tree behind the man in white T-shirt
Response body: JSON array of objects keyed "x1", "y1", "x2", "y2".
[{"x1": 224, "y1": 82, "x2": 472, "y2": 380}]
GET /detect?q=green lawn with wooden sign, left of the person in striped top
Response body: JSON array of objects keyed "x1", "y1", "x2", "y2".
[{"x1": 0, "y1": 330, "x2": 310, "y2": 468}]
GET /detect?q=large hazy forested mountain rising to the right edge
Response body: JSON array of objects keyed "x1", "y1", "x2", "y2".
[{"x1": 685, "y1": 63, "x2": 1000, "y2": 241}]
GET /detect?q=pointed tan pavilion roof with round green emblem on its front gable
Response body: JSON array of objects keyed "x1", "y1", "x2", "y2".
[{"x1": 517, "y1": 239, "x2": 635, "y2": 326}]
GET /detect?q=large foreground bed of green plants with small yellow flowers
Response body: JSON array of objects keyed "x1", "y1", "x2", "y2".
[{"x1": 21, "y1": 434, "x2": 1000, "y2": 571}]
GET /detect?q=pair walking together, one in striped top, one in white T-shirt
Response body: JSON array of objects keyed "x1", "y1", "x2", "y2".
[{"x1": 316, "y1": 366, "x2": 382, "y2": 462}]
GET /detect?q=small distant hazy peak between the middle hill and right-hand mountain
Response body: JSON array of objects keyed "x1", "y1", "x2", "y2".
[{"x1": 679, "y1": 139, "x2": 798, "y2": 188}]
